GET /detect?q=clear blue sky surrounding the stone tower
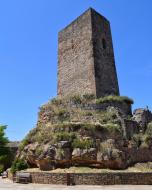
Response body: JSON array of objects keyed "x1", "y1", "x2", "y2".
[{"x1": 0, "y1": 0, "x2": 152, "y2": 140}]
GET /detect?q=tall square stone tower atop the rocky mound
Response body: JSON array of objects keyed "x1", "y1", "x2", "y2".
[{"x1": 58, "y1": 8, "x2": 119, "y2": 98}]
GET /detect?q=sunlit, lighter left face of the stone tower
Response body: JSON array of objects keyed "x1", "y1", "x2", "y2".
[{"x1": 58, "y1": 8, "x2": 95, "y2": 96}]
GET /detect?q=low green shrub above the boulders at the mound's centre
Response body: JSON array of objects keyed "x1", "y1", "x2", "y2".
[{"x1": 72, "y1": 139, "x2": 95, "y2": 149}]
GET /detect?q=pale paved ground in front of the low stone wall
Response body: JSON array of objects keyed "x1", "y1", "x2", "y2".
[{"x1": 0, "y1": 178, "x2": 152, "y2": 190}]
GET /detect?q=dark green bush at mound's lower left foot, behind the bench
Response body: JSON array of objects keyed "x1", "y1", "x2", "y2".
[{"x1": 11, "y1": 159, "x2": 28, "y2": 173}]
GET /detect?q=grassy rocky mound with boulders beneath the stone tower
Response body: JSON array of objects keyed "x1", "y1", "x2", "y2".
[{"x1": 17, "y1": 95, "x2": 152, "y2": 170}]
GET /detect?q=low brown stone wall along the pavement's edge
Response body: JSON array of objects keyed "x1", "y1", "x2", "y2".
[{"x1": 21, "y1": 172, "x2": 152, "y2": 185}]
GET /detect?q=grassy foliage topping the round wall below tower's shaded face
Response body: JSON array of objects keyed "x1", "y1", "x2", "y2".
[{"x1": 96, "y1": 96, "x2": 134, "y2": 104}]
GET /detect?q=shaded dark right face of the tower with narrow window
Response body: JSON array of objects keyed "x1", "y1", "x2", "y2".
[{"x1": 92, "y1": 11, "x2": 119, "y2": 98}]
